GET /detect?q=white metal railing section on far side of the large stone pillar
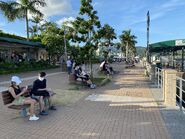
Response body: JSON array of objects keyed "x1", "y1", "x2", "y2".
[{"x1": 155, "y1": 67, "x2": 163, "y2": 90}]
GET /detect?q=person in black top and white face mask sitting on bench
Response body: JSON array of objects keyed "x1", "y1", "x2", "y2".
[{"x1": 31, "y1": 72, "x2": 56, "y2": 115}]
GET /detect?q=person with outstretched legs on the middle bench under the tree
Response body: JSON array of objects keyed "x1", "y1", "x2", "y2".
[{"x1": 74, "y1": 64, "x2": 96, "y2": 88}]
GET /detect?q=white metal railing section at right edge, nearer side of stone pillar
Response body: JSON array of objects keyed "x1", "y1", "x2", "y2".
[{"x1": 176, "y1": 77, "x2": 185, "y2": 111}]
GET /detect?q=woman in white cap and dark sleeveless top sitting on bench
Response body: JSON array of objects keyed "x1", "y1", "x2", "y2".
[{"x1": 8, "y1": 76, "x2": 39, "y2": 121}]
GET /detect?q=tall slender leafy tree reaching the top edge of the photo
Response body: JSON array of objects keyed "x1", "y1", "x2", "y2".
[{"x1": 73, "y1": 0, "x2": 101, "y2": 77}]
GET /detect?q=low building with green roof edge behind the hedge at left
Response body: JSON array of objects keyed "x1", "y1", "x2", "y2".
[{"x1": 0, "y1": 37, "x2": 47, "y2": 61}]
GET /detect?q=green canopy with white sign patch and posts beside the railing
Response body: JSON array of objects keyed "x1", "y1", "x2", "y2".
[{"x1": 149, "y1": 39, "x2": 185, "y2": 71}]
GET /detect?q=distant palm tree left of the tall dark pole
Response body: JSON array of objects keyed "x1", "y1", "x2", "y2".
[{"x1": 120, "y1": 30, "x2": 137, "y2": 61}]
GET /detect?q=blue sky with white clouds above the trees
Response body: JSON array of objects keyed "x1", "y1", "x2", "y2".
[{"x1": 0, "y1": 0, "x2": 185, "y2": 46}]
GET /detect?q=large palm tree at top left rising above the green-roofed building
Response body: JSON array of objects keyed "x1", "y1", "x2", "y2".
[{"x1": 0, "y1": 0, "x2": 46, "y2": 40}]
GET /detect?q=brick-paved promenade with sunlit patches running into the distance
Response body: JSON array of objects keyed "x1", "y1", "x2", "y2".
[{"x1": 0, "y1": 64, "x2": 184, "y2": 139}]
